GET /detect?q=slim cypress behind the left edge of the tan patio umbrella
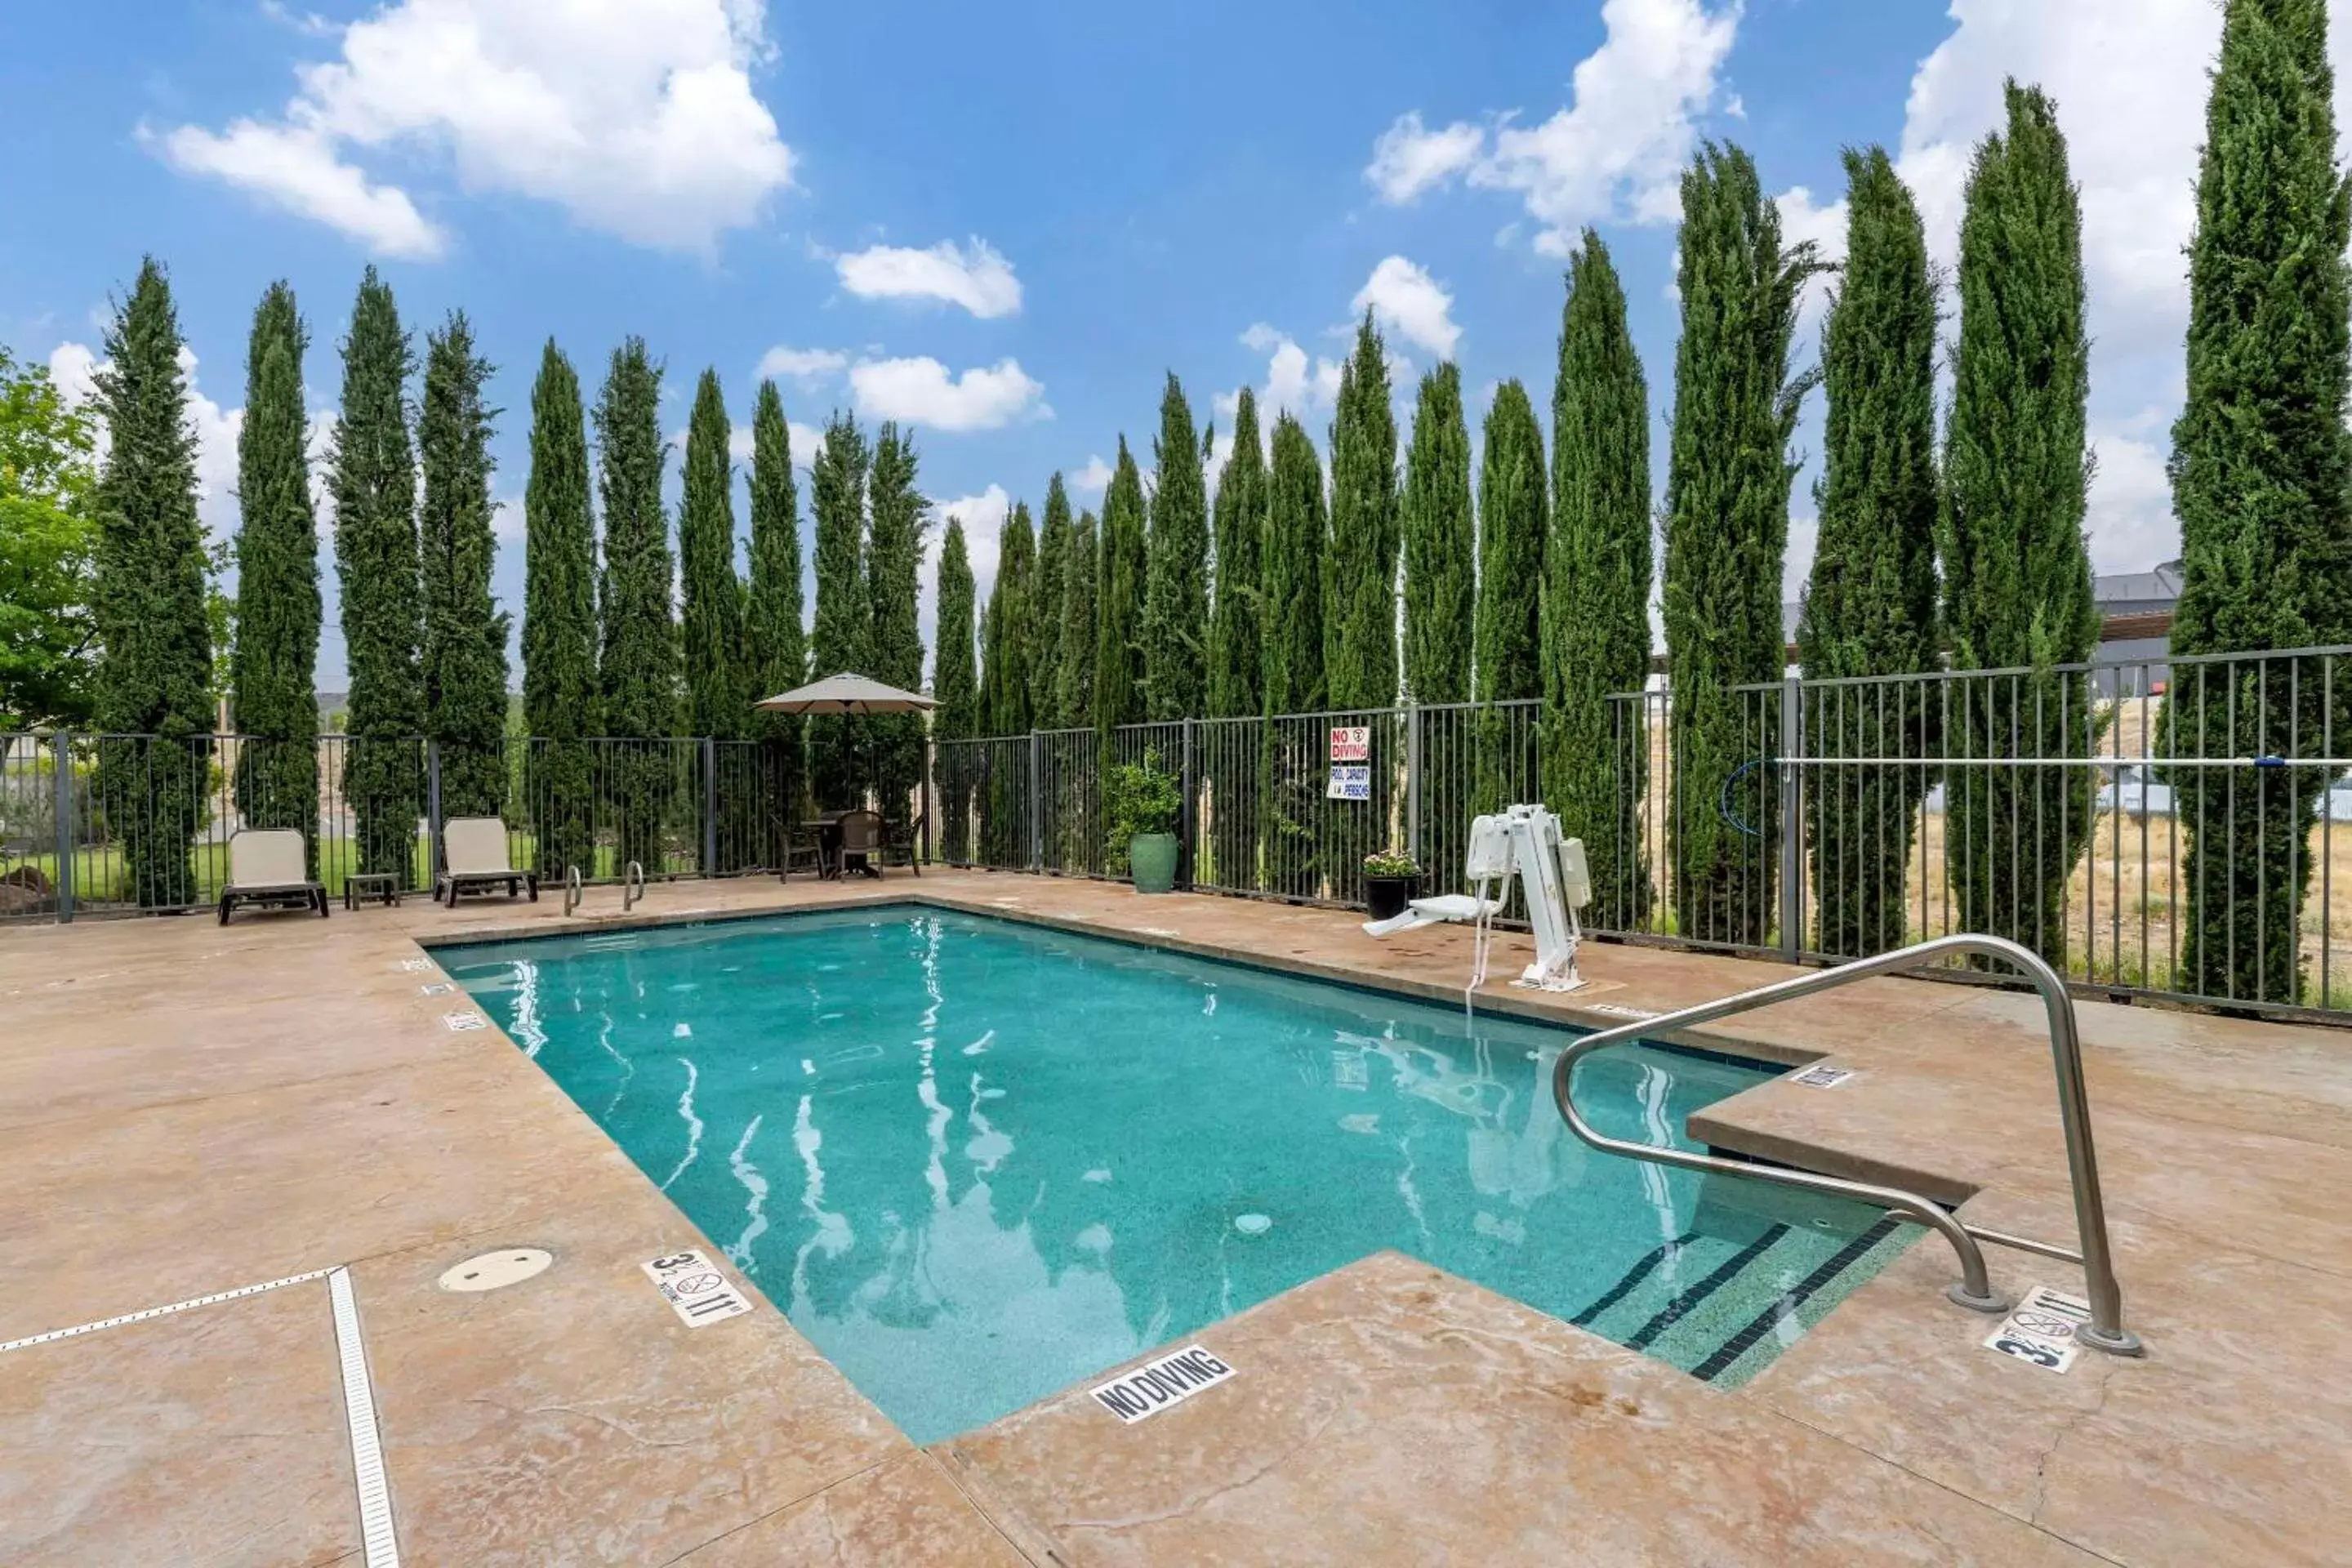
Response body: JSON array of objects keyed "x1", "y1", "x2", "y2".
[{"x1": 743, "y1": 381, "x2": 809, "y2": 865}]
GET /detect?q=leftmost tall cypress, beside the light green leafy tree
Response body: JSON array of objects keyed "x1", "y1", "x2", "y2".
[{"x1": 91, "y1": 256, "x2": 212, "y2": 910}]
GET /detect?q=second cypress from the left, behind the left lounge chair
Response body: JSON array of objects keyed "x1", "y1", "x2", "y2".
[{"x1": 228, "y1": 282, "x2": 324, "y2": 875}]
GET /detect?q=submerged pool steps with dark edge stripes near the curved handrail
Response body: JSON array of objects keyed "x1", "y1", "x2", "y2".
[{"x1": 1571, "y1": 1220, "x2": 1903, "y2": 1387}]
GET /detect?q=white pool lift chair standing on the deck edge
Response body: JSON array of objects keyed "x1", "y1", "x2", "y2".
[{"x1": 1364, "y1": 804, "x2": 1592, "y2": 992}]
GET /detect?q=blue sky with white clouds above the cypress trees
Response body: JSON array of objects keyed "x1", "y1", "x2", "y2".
[{"x1": 0, "y1": 0, "x2": 2314, "y2": 687}]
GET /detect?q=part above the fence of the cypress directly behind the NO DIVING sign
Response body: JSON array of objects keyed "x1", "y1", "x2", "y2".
[{"x1": 1324, "y1": 310, "x2": 1397, "y2": 710}]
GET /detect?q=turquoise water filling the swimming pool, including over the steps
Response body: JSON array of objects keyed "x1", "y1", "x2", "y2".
[{"x1": 435, "y1": 907, "x2": 1905, "y2": 1443}]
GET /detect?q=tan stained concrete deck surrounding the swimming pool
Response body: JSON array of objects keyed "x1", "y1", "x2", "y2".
[{"x1": 0, "y1": 872, "x2": 2352, "y2": 1568}]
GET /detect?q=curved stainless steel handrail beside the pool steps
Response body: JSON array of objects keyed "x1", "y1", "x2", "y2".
[{"x1": 1552, "y1": 936, "x2": 2143, "y2": 1356}]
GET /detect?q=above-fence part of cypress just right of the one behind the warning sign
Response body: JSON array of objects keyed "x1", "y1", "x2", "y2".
[{"x1": 1397, "y1": 359, "x2": 1477, "y2": 705}]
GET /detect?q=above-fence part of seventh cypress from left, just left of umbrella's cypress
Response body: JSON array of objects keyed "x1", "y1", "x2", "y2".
[{"x1": 677, "y1": 369, "x2": 738, "y2": 741}]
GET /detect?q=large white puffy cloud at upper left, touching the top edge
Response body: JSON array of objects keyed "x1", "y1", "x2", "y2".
[{"x1": 158, "y1": 0, "x2": 793, "y2": 256}]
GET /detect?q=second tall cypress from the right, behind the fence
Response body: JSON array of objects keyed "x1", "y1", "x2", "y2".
[{"x1": 1940, "y1": 82, "x2": 2098, "y2": 964}]
